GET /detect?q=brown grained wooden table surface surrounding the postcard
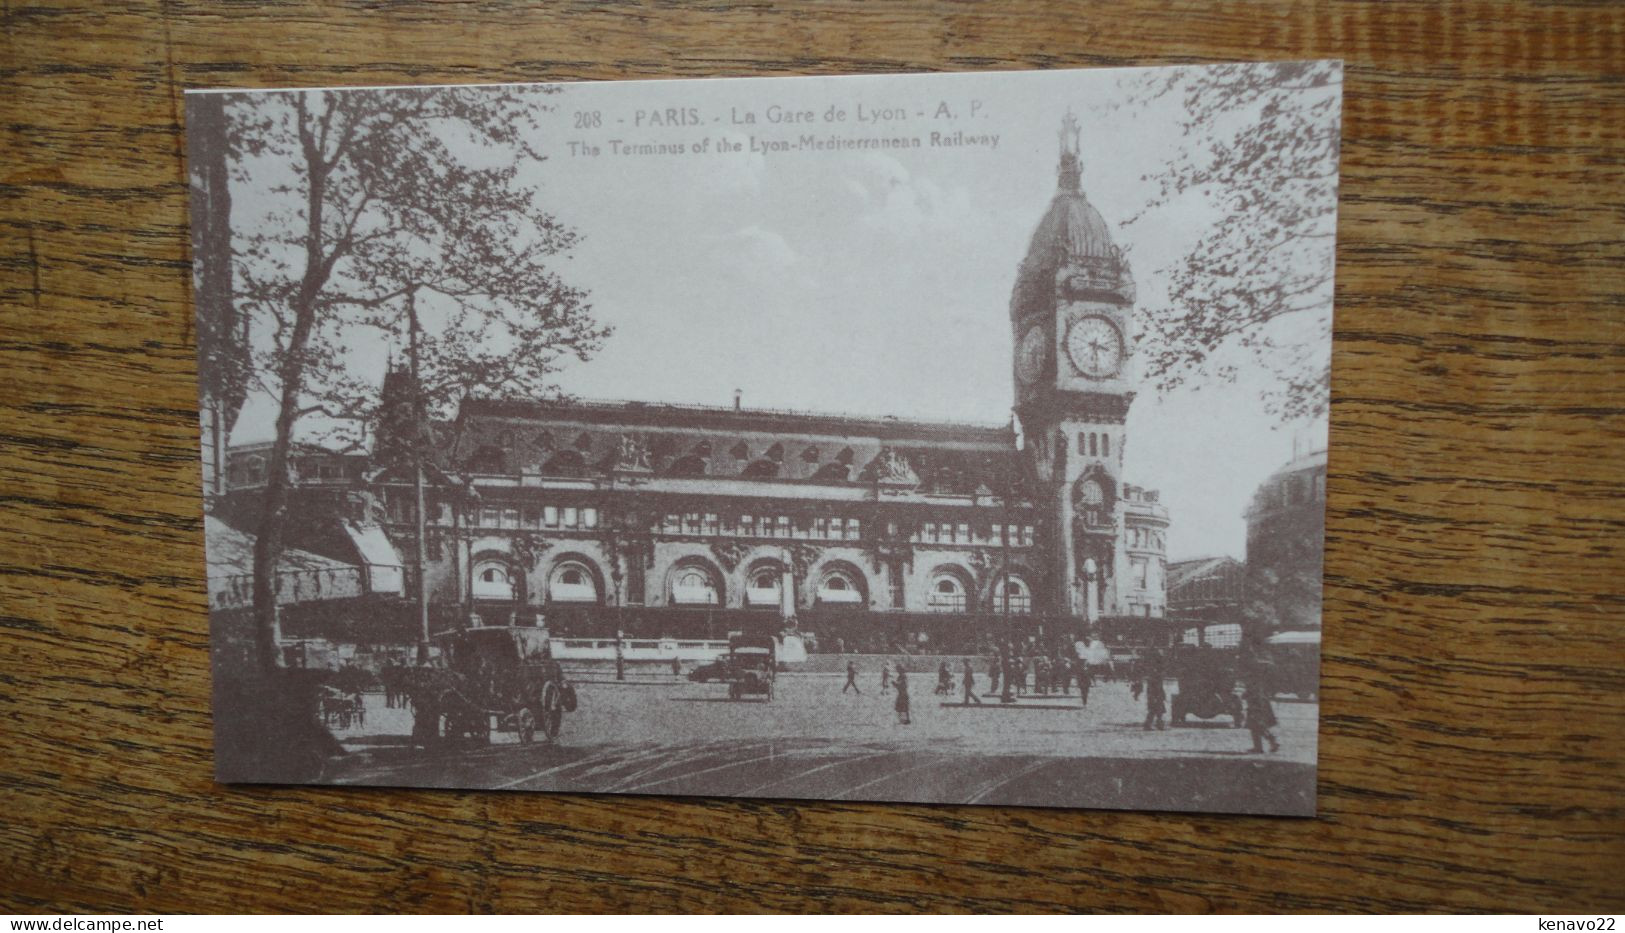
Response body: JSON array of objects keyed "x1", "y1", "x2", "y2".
[{"x1": 0, "y1": 0, "x2": 1625, "y2": 912}]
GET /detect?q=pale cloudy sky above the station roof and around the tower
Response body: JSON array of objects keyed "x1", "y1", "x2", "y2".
[{"x1": 219, "y1": 70, "x2": 1329, "y2": 559}]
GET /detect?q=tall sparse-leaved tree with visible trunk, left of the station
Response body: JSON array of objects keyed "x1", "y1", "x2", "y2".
[{"x1": 219, "y1": 88, "x2": 608, "y2": 666}]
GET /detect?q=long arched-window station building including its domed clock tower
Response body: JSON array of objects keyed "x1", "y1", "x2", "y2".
[{"x1": 212, "y1": 119, "x2": 1168, "y2": 650}]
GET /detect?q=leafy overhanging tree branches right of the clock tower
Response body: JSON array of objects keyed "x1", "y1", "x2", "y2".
[{"x1": 1123, "y1": 62, "x2": 1342, "y2": 423}]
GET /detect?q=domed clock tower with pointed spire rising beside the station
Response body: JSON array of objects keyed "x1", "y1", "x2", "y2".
[{"x1": 1011, "y1": 114, "x2": 1134, "y2": 621}]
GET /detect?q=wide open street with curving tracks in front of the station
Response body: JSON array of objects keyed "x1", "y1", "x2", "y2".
[{"x1": 328, "y1": 671, "x2": 1318, "y2": 813}]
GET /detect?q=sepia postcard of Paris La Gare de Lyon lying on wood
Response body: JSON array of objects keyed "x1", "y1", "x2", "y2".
[{"x1": 187, "y1": 62, "x2": 1342, "y2": 814}]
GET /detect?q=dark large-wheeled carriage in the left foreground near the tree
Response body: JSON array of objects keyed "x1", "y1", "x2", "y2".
[{"x1": 406, "y1": 626, "x2": 577, "y2": 746}]
